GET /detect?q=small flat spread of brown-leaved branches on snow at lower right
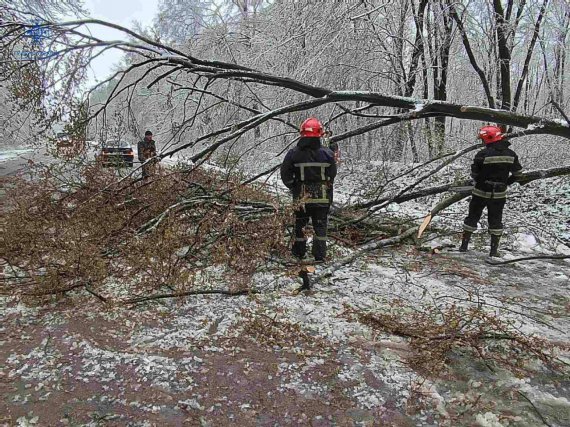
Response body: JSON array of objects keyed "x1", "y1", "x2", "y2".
[{"x1": 345, "y1": 301, "x2": 569, "y2": 376}]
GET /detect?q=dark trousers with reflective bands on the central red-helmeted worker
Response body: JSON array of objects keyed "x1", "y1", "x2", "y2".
[{"x1": 291, "y1": 204, "x2": 329, "y2": 261}]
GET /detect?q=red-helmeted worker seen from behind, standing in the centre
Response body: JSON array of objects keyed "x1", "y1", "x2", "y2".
[{"x1": 281, "y1": 117, "x2": 336, "y2": 261}]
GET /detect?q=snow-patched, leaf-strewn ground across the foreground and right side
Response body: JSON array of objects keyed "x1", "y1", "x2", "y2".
[{"x1": 0, "y1": 158, "x2": 570, "y2": 426}]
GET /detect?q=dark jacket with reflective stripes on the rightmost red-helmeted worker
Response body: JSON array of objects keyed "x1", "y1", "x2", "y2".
[{"x1": 471, "y1": 141, "x2": 522, "y2": 199}]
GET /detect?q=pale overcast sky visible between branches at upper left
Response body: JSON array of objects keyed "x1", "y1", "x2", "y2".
[{"x1": 84, "y1": 0, "x2": 158, "y2": 85}]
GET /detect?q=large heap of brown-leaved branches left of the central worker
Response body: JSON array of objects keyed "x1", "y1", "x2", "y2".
[{"x1": 0, "y1": 165, "x2": 291, "y2": 301}]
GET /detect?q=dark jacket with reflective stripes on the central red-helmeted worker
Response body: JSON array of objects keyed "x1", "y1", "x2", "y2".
[{"x1": 281, "y1": 138, "x2": 336, "y2": 207}]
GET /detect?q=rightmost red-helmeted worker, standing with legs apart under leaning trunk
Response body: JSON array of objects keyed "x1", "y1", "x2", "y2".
[{"x1": 459, "y1": 126, "x2": 522, "y2": 257}]
